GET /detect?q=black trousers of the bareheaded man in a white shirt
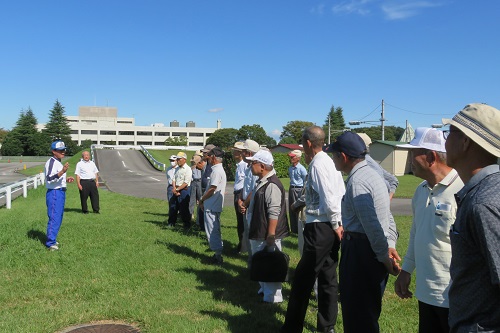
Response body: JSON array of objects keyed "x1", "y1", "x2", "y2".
[{"x1": 281, "y1": 222, "x2": 340, "y2": 333}]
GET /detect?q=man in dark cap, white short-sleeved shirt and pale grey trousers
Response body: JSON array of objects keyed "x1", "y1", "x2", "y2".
[{"x1": 200, "y1": 147, "x2": 226, "y2": 265}]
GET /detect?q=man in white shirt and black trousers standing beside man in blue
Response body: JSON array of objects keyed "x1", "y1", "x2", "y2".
[{"x1": 75, "y1": 151, "x2": 99, "y2": 214}]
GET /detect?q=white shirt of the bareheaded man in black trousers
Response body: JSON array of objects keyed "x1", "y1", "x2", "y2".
[{"x1": 305, "y1": 151, "x2": 346, "y2": 229}]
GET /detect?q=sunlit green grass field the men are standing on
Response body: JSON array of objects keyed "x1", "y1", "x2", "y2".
[{"x1": 0, "y1": 157, "x2": 418, "y2": 333}]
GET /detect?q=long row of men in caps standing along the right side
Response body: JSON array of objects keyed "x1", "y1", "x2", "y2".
[{"x1": 163, "y1": 104, "x2": 500, "y2": 333}]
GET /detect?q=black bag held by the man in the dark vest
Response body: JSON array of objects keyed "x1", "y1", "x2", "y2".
[{"x1": 250, "y1": 246, "x2": 290, "y2": 282}]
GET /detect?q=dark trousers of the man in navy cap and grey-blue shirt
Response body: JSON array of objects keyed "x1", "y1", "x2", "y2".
[{"x1": 339, "y1": 233, "x2": 389, "y2": 333}]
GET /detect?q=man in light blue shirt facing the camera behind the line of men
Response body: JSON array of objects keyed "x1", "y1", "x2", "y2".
[{"x1": 288, "y1": 149, "x2": 307, "y2": 234}]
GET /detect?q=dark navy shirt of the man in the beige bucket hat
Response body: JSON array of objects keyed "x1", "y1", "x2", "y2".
[{"x1": 449, "y1": 164, "x2": 500, "y2": 332}]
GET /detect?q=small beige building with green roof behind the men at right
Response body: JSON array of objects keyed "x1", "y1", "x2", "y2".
[{"x1": 370, "y1": 140, "x2": 411, "y2": 176}]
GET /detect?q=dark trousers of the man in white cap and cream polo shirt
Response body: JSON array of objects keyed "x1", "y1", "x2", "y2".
[{"x1": 418, "y1": 301, "x2": 450, "y2": 333}]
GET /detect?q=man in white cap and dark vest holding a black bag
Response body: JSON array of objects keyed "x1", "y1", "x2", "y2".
[{"x1": 247, "y1": 150, "x2": 289, "y2": 303}]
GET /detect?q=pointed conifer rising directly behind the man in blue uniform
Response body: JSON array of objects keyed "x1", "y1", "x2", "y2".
[{"x1": 43, "y1": 100, "x2": 78, "y2": 155}]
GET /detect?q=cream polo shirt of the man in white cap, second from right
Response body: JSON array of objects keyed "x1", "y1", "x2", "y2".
[{"x1": 402, "y1": 170, "x2": 464, "y2": 308}]
